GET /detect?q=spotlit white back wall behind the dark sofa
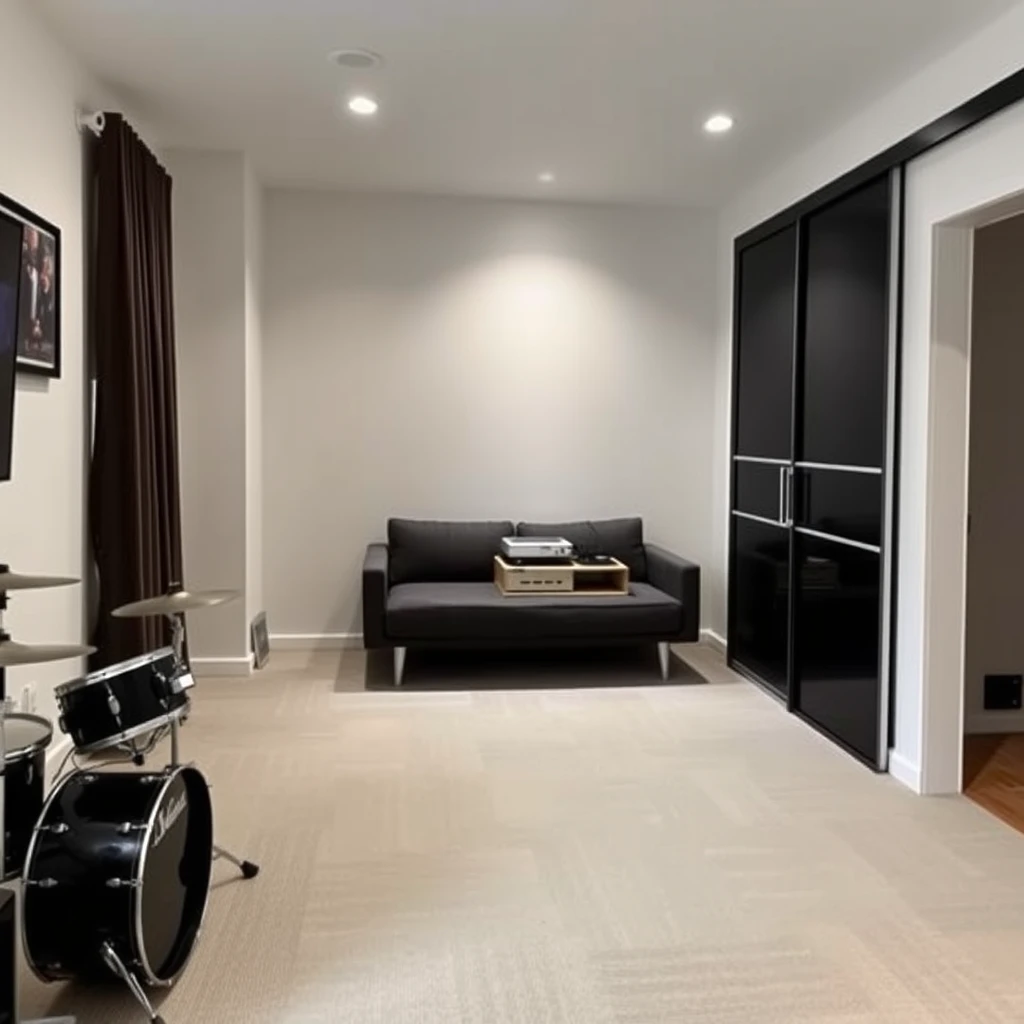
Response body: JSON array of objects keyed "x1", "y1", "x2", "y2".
[{"x1": 263, "y1": 190, "x2": 715, "y2": 636}]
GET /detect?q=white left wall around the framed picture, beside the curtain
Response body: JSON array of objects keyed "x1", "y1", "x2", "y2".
[{"x1": 0, "y1": 0, "x2": 128, "y2": 739}]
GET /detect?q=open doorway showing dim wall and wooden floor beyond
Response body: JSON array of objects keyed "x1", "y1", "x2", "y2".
[{"x1": 963, "y1": 215, "x2": 1024, "y2": 831}]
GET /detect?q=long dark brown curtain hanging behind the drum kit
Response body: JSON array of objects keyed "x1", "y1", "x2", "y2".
[{"x1": 89, "y1": 114, "x2": 181, "y2": 670}]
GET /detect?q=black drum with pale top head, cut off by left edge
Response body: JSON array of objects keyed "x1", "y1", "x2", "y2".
[{"x1": 2, "y1": 715, "x2": 53, "y2": 882}]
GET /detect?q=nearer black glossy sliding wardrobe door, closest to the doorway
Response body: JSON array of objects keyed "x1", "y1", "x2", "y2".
[{"x1": 793, "y1": 175, "x2": 892, "y2": 762}]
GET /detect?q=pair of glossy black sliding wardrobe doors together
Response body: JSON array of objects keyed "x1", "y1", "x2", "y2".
[{"x1": 729, "y1": 174, "x2": 894, "y2": 767}]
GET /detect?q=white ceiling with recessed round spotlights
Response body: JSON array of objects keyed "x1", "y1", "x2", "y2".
[{"x1": 32, "y1": 0, "x2": 1015, "y2": 205}]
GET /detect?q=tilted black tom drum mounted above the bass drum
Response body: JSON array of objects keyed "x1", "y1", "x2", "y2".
[{"x1": 54, "y1": 647, "x2": 189, "y2": 753}]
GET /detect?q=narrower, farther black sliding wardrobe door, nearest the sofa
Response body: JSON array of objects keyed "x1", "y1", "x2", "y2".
[{"x1": 729, "y1": 226, "x2": 798, "y2": 696}]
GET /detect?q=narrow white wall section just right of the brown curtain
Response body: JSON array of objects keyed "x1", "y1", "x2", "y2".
[{"x1": 165, "y1": 150, "x2": 249, "y2": 673}]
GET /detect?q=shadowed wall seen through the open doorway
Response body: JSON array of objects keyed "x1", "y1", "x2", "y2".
[{"x1": 965, "y1": 217, "x2": 1024, "y2": 732}]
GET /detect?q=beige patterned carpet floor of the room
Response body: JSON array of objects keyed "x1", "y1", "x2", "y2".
[{"x1": 16, "y1": 648, "x2": 1024, "y2": 1024}]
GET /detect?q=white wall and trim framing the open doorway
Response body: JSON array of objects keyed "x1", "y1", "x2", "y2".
[{"x1": 892, "y1": 96, "x2": 1024, "y2": 794}]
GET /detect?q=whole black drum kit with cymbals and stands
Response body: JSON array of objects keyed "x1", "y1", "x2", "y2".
[{"x1": 0, "y1": 565, "x2": 259, "y2": 1024}]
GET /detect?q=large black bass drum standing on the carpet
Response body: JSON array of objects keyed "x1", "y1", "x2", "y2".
[{"x1": 22, "y1": 767, "x2": 213, "y2": 985}]
